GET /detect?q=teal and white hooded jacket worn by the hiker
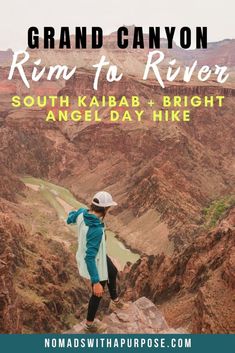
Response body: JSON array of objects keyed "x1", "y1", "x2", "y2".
[{"x1": 67, "y1": 208, "x2": 108, "y2": 283}]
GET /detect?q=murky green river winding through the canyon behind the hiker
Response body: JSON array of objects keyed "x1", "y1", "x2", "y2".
[{"x1": 21, "y1": 177, "x2": 139, "y2": 269}]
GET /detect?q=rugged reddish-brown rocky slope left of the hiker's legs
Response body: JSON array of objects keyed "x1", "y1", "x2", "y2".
[{"x1": 0, "y1": 213, "x2": 88, "y2": 333}]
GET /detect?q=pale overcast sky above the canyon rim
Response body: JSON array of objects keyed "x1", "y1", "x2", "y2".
[{"x1": 0, "y1": 0, "x2": 235, "y2": 50}]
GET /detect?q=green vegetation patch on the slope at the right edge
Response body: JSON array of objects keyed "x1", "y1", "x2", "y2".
[{"x1": 203, "y1": 196, "x2": 235, "y2": 228}]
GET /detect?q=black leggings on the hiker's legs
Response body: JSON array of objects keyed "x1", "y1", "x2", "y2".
[{"x1": 87, "y1": 256, "x2": 118, "y2": 321}]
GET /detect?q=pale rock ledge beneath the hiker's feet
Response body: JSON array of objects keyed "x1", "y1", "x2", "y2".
[{"x1": 67, "y1": 297, "x2": 184, "y2": 334}]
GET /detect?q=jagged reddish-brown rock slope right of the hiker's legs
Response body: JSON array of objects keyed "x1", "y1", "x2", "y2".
[{"x1": 123, "y1": 208, "x2": 235, "y2": 333}]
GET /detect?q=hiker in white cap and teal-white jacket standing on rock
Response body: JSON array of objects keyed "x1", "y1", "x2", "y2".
[{"x1": 67, "y1": 191, "x2": 127, "y2": 332}]
